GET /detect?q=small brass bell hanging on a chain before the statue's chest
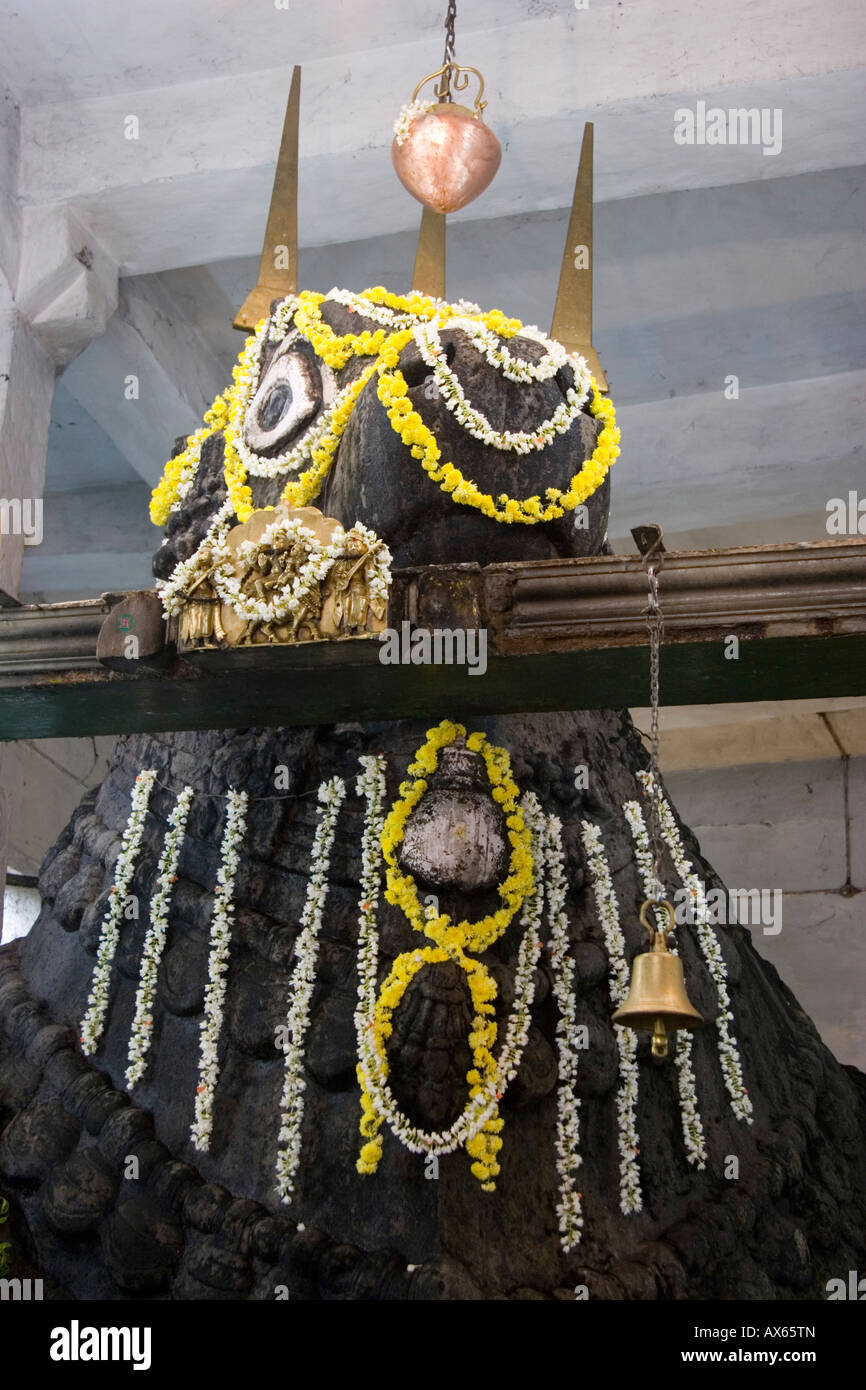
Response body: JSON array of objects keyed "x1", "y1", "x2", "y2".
[{"x1": 613, "y1": 901, "x2": 703, "y2": 1056}]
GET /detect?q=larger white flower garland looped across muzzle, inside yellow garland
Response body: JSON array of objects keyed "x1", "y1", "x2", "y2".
[{"x1": 414, "y1": 318, "x2": 592, "y2": 453}]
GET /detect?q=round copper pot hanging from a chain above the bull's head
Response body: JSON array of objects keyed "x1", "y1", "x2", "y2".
[{"x1": 391, "y1": 63, "x2": 502, "y2": 213}]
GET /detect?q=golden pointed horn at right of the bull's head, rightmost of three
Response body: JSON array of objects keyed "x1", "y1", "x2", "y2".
[{"x1": 550, "y1": 121, "x2": 607, "y2": 391}]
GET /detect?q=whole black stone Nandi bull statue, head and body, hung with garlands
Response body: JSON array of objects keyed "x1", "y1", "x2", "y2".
[{"x1": 0, "y1": 154, "x2": 866, "y2": 1300}]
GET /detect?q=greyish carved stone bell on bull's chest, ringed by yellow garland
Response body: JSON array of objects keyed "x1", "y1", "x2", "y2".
[{"x1": 400, "y1": 738, "x2": 507, "y2": 892}]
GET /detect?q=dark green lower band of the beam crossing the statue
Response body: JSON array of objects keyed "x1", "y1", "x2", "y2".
[{"x1": 0, "y1": 634, "x2": 866, "y2": 739}]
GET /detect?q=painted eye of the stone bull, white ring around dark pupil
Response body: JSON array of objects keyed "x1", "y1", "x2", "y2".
[{"x1": 243, "y1": 332, "x2": 335, "y2": 459}]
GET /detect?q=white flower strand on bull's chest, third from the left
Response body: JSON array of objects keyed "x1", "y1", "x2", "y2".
[{"x1": 189, "y1": 787, "x2": 247, "y2": 1152}]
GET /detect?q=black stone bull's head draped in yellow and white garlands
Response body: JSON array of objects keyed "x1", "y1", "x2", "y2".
[{"x1": 152, "y1": 288, "x2": 619, "y2": 577}]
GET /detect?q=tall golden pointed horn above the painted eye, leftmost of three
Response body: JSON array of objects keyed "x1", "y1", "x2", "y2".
[{"x1": 235, "y1": 65, "x2": 300, "y2": 332}]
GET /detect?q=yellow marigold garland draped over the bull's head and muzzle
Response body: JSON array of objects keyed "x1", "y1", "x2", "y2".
[{"x1": 150, "y1": 285, "x2": 620, "y2": 525}]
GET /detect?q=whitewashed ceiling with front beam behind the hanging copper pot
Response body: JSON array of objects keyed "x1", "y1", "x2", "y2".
[{"x1": 10, "y1": 0, "x2": 866, "y2": 274}]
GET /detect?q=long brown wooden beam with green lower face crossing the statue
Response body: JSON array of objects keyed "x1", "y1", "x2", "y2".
[{"x1": 0, "y1": 541, "x2": 866, "y2": 739}]
